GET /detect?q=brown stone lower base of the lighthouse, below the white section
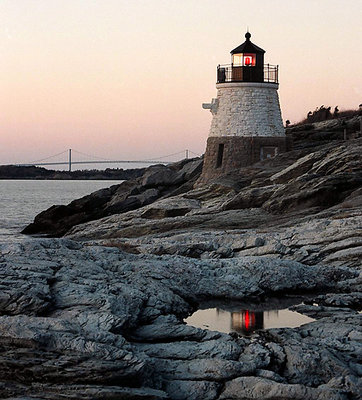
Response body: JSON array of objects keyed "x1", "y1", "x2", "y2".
[{"x1": 199, "y1": 136, "x2": 291, "y2": 183}]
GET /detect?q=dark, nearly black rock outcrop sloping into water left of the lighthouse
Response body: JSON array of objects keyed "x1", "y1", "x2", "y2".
[{"x1": 22, "y1": 159, "x2": 202, "y2": 237}]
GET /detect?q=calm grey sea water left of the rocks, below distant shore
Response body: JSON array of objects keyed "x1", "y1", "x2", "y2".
[{"x1": 0, "y1": 180, "x2": 122, "y2": 242}]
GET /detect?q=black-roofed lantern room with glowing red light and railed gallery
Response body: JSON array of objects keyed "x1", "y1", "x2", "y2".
[{"x1": 217, "y1": 32, "x2": 278, "y2": 83}]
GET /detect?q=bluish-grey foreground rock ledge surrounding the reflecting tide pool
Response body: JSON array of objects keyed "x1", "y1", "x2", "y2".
[{"x1": 0, "y1": 239, "x2": 361, "y2": 400}]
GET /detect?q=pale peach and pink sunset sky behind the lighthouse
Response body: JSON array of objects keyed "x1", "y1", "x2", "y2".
[{"x1": 0, "y1": 0, "x2": 362, "y2": 164}]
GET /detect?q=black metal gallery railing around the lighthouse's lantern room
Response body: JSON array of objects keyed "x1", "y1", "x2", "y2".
[{"x1": 217, "y1": 64, "x2": 279, "y2": 83}]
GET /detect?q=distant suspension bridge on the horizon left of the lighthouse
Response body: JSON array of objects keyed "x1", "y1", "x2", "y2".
[{"x1": 13, "y1": 149, "x2": 200, "y2": 172}]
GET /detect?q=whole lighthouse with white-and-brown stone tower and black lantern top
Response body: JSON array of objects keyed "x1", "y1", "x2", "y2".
[{"x1": 200, "y1": 32, "x2": 286, "y2": 182}]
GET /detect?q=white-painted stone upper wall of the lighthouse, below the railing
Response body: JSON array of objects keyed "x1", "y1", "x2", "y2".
[{"x1": 209, "y1": 82, "x2": 285, "y2": 137}]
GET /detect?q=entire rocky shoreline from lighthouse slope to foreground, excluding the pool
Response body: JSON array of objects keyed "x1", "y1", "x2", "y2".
[{"x1": 0, "y1": 119, "x2": 362, "y2": 400}]
